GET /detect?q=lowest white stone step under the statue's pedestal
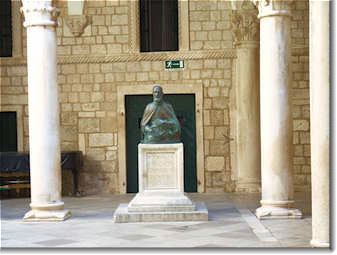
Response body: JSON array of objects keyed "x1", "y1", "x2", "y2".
[{"x1": 113, "y1": 202, "x2": 208, "y2": 223}]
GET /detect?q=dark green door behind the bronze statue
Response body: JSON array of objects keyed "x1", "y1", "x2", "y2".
[{"x1": 125, "y1": 94, "x2": 197, "y2": 193}]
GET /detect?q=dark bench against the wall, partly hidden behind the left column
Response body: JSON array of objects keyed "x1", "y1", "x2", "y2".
[{"x1": 0, "y1": 151, "x2": 83, "y2": 195}]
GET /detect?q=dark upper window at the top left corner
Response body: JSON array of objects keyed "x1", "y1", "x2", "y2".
[{"x1": 0, "y1": 0, "x2": 13, "y2": 57}]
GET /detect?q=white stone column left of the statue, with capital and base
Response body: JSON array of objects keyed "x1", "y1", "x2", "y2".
[{"x1": 22, "y1": 0, "x2": 70, "y2": 221}]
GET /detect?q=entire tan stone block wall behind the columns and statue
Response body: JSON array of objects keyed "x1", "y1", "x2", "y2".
[{"x1": 0, "y1": 0, "x2": 310, "y2": 194}]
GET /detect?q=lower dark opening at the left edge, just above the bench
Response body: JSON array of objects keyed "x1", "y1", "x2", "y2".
[{"x1": 0, "y1": 111, "x2": 18, "y2": 152}]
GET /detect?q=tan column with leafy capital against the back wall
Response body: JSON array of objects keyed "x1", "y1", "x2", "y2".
[{"x1": 232, "y1": 7, "x2": 261, "y2": 192}]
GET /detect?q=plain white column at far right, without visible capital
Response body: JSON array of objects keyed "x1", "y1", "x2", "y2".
[{"x1": 310, "y1": 1, "x2": 330, "y2": 247}]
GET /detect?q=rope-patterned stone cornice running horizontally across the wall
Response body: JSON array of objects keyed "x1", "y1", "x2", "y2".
[{"x1": 0, "y1": 46, "x2": 309, "y2": 66}]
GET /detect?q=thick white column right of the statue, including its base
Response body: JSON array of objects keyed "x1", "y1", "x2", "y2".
[{"x1": 254, "y1": 0, "x2": 302, "y2": 219}]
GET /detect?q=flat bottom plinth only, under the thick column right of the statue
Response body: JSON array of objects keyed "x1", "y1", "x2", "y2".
[{"x1": 255, "y1": 205, "x2": 302, "y2": 220}]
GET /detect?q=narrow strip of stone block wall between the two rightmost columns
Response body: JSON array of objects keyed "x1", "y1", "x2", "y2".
[{"x1": 291, "y1": 1, "x2": 311, "y2": 191}]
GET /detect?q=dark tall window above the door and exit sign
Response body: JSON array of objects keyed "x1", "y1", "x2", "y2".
[{"x1": 139, "y1": 0, "x2": 179, "y2": 52}]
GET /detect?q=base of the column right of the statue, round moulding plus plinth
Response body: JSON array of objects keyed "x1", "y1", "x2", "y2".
[{"x1": 255, "y1": 200, "x2": 302, "y2": 220}]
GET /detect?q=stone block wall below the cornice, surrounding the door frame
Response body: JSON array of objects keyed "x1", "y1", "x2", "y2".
[{"x1": 55, "y1": 59, "x2": 232, "y2": 193}]
